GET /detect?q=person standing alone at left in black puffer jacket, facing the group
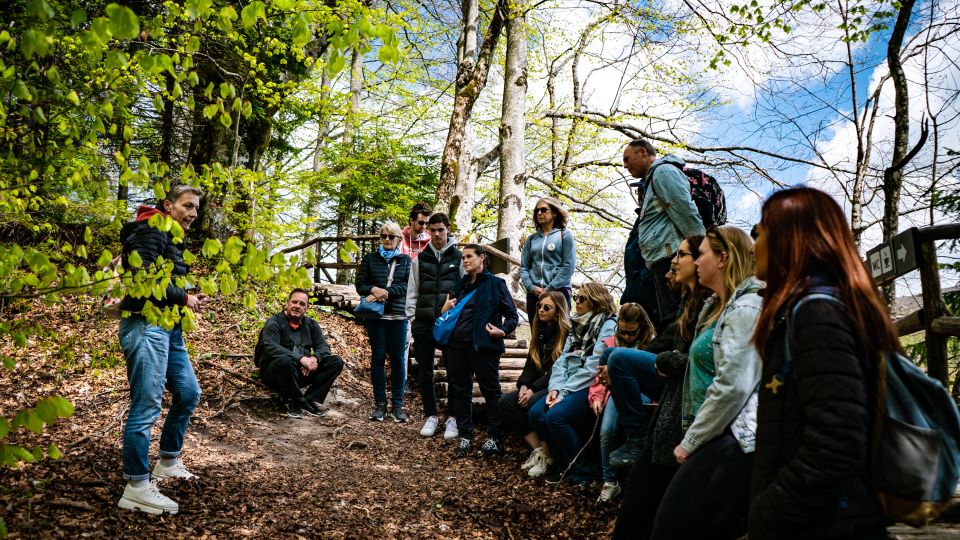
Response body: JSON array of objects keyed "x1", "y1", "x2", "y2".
[{"x1": 118, "y1": 185, "x2": 206, "y2": 514}]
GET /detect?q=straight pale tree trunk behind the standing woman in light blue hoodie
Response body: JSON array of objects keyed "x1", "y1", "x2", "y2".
[{"x1": 497, "y1": 0, "x2": 527, "y2": 254}]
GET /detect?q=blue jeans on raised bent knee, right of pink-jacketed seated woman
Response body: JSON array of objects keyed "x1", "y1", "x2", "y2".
[{"x1": 604, "y1": 347, "x2": 666, "y2": 440}]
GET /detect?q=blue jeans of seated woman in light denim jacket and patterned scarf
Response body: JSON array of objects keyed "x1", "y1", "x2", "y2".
[{"x1": 530, "y1": 388, "x2": 596, "y2": 482}]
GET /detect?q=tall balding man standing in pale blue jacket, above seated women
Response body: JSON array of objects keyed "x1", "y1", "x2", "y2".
[{"x1": 623, "y1": 139, "x2": 704, "y2": 332}]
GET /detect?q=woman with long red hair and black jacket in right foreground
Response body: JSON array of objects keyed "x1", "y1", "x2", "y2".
[{"x1": 749, "y1": 187, "x2": 900, "y2": 540}]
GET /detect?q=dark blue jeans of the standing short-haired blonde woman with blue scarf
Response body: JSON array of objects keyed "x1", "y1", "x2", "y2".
[{"x1": 366, "y1": 319, "x2": 409, "y2": 407}]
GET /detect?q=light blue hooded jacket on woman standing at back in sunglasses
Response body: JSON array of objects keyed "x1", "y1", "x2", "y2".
[{"x1": 520, "y1": 229, "x2": 577, "y2": 291}]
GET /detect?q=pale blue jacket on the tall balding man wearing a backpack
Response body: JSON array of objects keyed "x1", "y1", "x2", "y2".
[{"x1": 636, "y1": 155, "x2": 704, "y2": 266}]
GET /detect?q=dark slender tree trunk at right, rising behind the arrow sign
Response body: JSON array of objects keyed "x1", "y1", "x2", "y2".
[{"x1": 883, "y1": 0, "x2": 915, "y2": 306}]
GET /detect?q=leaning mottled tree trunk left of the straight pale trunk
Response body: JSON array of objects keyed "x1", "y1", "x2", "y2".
[{"x1": 434, "y1": 0, "x2": 507, "y2": 212}]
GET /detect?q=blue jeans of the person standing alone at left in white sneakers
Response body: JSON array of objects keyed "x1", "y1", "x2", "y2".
[{"x1": 120, "y1": 315, "x2": 200, "y2": 480}]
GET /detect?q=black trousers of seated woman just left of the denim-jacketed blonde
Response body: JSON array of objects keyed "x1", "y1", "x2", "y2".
[{"x1": 613, "y1": 439, "x2": 679, "y2": 540}]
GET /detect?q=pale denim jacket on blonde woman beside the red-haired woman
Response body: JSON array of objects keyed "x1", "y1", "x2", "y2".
[{"x1": 680, "y1": 276, "x2": 763, "y2": 454}]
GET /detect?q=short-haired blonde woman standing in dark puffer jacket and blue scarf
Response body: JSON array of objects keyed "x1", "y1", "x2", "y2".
[{"x1": 356, "y1": 222, "x2": 411, "y2": 423}]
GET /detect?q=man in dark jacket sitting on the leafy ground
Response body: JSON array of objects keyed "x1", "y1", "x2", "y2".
[{"x1": 254, "y1": 289, "x2": 343, "y2": 418}]
